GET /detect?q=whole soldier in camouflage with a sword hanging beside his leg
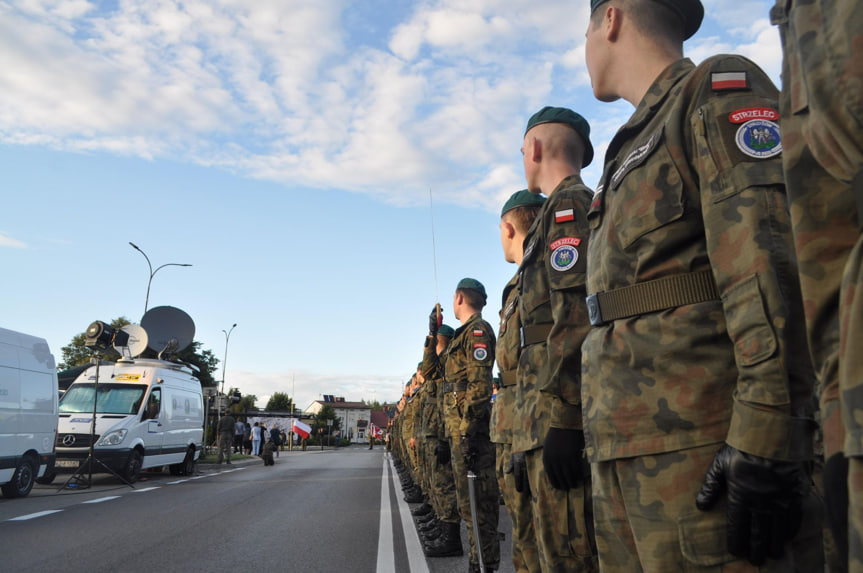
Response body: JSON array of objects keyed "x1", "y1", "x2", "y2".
[{"x1": 430, "y1": 278, "x2": 500, "y2": 571}]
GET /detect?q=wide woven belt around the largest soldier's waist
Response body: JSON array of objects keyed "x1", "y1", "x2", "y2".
[{"x1": 587, "y1": 270, "x2": 719, "y2": 326}]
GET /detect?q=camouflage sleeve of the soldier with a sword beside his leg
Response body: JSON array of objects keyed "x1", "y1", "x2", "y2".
[{"x1": 460, "y1": 323, "x2": 495, "y2": 434}]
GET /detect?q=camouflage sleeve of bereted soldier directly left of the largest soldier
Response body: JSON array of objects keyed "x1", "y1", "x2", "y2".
[{"x1": 538, "y1": 189, "x2": 590, "y2": 430}]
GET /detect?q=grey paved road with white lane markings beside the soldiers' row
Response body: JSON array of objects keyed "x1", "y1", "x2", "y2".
[{"x1": 0, "y1": 447, "x2": 512, "y2": 573}]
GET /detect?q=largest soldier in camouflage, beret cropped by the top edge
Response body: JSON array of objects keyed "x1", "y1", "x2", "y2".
[{"x1": 582, "y1": 0, "x2": 823, "y2": 571}]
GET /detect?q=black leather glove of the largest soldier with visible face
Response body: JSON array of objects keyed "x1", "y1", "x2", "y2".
[{"x1": 695, "y1": 444, "x2": 808, "y2": 566}]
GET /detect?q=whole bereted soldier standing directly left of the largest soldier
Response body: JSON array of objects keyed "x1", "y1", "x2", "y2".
[{"x1": 513, "y1": 107, "x2": 597, "y2": 571}]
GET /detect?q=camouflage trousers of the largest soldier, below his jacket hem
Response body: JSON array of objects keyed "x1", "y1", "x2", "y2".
[{"x1": 591, "y1": 444, "x2": 824, "y2": 573}]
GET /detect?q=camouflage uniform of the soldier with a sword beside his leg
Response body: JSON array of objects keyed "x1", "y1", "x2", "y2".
[{"x1": 443, "y1": 313, "x2": 500, "y2": 569}]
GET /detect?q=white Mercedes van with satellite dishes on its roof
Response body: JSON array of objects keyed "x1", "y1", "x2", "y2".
[{"x1": 56, "y1": 307, "x2": 204, "y2": 483}]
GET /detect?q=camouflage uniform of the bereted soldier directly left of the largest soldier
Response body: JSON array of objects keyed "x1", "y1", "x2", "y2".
[{"x1": 513, "y1": 175, "x2": 597, "y2": 571}]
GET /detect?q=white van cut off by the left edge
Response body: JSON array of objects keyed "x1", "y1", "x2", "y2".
[{"x1": 0, "y1": 328, "x2": 57, "y2": 497}]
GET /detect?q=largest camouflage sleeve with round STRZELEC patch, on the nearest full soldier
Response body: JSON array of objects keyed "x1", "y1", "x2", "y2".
[{"x1": 690, "y1": 58, "x2": 814, "y2": 460}]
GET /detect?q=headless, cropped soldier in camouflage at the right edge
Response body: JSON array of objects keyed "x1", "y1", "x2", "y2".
[{"x1": 770, "y1": 0, "x2": 863, "y2": 570}]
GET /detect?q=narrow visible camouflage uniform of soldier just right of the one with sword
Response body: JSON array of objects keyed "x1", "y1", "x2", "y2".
[{"x1": 489, "y1": 274, "x2": 541, "y2": 572}]
